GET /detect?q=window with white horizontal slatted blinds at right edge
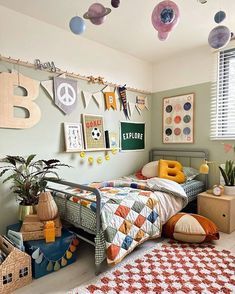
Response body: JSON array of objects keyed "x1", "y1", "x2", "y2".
[{"x1": 211, "y1": 48, "x2": 235, "y2": 140}]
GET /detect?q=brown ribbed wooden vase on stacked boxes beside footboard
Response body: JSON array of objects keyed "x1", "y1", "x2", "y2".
[{"x1": 37, "y1": 192, "x2": 58, "y2": 221}]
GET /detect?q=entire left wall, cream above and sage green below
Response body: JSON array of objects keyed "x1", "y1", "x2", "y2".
[{"x1": 0, "y1": 6, "x2": 152, "y2": 233}]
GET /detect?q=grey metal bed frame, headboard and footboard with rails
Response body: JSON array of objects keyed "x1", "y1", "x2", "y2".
[{"x1": 48, "y1": 148, "x2": 208, "y2": 274}]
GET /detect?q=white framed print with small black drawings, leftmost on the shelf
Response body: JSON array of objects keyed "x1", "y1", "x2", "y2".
[{"x1": 64, "y1": 123, "x2": 84, "y2": 152}]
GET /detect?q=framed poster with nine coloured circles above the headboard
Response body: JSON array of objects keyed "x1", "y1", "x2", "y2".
[{"x1": 162, "y1": 93, "x2": 194, "y2": 143}]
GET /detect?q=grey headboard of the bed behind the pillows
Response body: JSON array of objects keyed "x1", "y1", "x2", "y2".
[{"x1": 149, "y1": 148, "x2": 209, "y2": 187}]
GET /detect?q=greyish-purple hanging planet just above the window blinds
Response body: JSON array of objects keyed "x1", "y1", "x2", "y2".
[{"x1": 208, "y1": 26, "x2": 231, "y2": 49}]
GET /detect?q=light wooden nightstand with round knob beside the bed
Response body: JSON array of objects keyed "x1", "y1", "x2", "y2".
[{"x1": 197, "y1": 192, "x2": 235, "y2": 234}]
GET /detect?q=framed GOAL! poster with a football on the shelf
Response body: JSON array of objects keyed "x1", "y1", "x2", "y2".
[{"x1": 82, "y1": 114, "x2": 105, "y2": 150}]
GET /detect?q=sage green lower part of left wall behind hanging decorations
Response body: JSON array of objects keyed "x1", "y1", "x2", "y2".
[{"x1": 0, "y1": 62, "x2": 151, "y2": 233}]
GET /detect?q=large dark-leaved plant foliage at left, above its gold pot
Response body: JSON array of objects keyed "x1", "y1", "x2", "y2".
[{"x1": 0, "y1": 154, "x2": 70, "y2": 205}]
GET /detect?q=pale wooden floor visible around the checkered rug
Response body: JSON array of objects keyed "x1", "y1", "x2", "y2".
[{"x1": 14, "y1": 231, "x2": 235, "y2": 294}]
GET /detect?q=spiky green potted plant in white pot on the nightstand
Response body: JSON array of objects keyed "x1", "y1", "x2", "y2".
[{"x1": 219, "y1": 160, "x2": 235, "y2": 195}]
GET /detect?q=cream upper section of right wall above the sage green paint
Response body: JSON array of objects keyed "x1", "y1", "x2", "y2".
[{"x1": 153, "y1": 45, "x2": 215, "y2": 93}]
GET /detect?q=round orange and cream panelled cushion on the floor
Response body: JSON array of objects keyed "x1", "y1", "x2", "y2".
[{"x1": 163, "y1": 212, "x2": 219, "y2": 243}]
